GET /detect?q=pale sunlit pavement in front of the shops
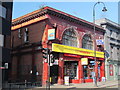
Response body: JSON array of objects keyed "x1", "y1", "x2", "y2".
[{"x1": 29, "y1": 80, "x2": 120, "y2": 90}]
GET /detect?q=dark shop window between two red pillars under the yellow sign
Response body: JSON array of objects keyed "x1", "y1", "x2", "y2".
[{"x1": 64, "y1": 61, "x2": 78, "y2": 79}]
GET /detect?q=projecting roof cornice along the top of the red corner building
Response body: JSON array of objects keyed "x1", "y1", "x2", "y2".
[{"x1": 12, "y1": 6, "x2": 105, "y2": 32}]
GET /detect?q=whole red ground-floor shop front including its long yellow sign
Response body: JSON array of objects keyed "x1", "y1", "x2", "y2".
[{"x1": 52, "y1": 43, "x2": 105, "y2": 84}]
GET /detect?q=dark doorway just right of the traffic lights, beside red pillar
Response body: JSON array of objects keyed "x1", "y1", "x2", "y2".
[{"x1": 50, "y1": 65, "x2": 58, "y2": 84}]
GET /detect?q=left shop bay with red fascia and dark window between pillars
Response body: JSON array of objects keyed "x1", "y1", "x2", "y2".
[{"x1": 63, "y1": 53, "x2": 80, "y2": 83}]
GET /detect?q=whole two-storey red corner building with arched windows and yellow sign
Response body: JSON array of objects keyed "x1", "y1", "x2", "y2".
[{"x1": 11, "y1": 7, "x2": 105, "y2": 85}]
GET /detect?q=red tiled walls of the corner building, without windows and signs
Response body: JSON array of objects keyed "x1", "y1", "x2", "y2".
[{"x1": 11, "y1": 7, "x2": 104, "y2": 85}]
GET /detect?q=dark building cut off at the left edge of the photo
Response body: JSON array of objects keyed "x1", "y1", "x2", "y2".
[{"x1": 0, "y1": 1, "x2": 12, "y2": 87}]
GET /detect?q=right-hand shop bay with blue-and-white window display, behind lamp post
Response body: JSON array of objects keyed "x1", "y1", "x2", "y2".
[{"x1": 82, "y1": 57, "x2": 105, "y2": 83}]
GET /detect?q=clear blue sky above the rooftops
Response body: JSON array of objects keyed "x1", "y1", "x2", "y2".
[{"x1": 12, "y1": 0, "x2": 118, "y2": 23}]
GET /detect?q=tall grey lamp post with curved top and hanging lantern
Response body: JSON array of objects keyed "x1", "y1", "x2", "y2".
[{"x1": 93, "y1": 2, "x2": 107, "y2": 87}]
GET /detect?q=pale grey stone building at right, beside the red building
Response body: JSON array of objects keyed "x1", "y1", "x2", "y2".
[{"x1": 96, "y1": 18, "x2": 120, "y2": 80}]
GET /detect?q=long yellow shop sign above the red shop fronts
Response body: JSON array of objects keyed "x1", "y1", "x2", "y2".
[{"x1": 52, "y1": 43, "x2": 104, "y2": 58}]
